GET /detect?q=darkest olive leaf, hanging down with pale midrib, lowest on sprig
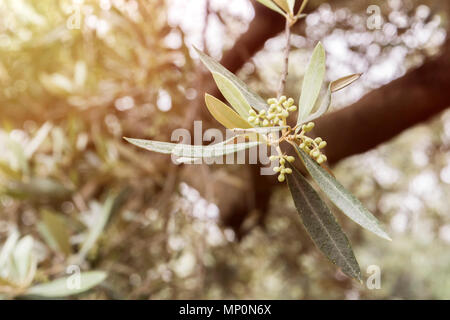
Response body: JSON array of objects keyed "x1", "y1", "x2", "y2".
[{"x1": 287, "y1": 165, "x2": 361, "y2": 281}]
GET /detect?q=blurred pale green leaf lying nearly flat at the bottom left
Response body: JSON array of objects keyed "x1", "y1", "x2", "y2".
[{"x1": 25, "y1": 271, "x2": 107, "y2": 298}]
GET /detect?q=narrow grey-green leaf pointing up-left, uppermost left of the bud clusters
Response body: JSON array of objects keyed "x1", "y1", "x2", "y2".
[{"x1": 194, "y1": 47, "x2": 268, "y2": 110}]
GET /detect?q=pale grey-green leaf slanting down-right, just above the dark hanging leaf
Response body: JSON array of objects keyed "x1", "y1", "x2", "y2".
[{"x1": 296, "y1": 147, "x2": 391, "y2": 240}]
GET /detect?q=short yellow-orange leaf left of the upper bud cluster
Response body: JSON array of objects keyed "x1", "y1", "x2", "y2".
[{"x1": 205, "y1": 94, "x2": 252, "y2": 129}]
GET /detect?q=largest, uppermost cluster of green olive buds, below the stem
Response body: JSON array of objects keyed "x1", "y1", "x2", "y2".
[{"x1": 248, "y1": 96, "x2": 297, "y2": 127}]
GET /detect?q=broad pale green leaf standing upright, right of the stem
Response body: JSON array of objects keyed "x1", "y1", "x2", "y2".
[{"x1": 297, "y1": 42, "x2": 325, "y2": 123}]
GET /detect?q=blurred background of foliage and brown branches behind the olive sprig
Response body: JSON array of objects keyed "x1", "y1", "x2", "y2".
[{"x1": 0, "y1": 0, "x2": 450, "y2": 299}]
